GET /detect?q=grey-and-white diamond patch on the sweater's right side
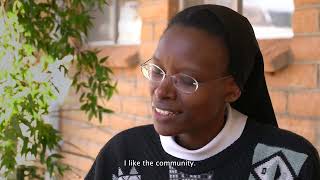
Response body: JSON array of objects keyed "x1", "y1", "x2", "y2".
[{"x1": 249, "y1": 143, "x2": 308, "y2": 180}]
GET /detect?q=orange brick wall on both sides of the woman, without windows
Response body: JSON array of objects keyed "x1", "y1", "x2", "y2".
[{"x1": 60, "y1": 0, "x2": 320, "y2": 179}]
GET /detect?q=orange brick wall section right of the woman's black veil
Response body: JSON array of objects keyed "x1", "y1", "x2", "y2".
[{"x1": 266, "y1": 0, "x2": 320, "y2": 150}]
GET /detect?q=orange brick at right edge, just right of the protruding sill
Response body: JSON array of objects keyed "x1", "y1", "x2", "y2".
[{"x1": 291, "y1": 36, "x2": 320, "y2": 61}]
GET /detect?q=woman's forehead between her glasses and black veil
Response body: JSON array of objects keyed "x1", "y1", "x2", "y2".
[{"x1": 154, "y1": 25, "x2": 229, "y2": 74}]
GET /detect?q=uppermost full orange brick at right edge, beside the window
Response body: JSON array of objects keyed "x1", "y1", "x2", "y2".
[{"x1": 292, "y1": 8, "x2": 320, "y2": 33}]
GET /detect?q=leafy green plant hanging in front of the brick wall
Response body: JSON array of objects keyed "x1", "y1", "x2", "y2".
[{"x1": 0, "y1": 0, "x2": 116, "y2": 179}]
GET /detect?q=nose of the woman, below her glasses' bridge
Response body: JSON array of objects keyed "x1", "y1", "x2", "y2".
[{"x1": 154, "y1": 76, "x2": 177, "y2": 100}]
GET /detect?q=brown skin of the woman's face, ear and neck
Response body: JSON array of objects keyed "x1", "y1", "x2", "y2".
[{"x1": 150, "y1": 25, "x2": 241, "y2": 149}]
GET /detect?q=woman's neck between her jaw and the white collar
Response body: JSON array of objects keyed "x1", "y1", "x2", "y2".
[{"x1": 175, "y1": 108, "x2": 227, "y2": 150}]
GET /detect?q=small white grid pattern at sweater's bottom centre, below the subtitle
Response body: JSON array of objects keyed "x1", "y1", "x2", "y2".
[{"x1": 169, "y1": 166, "x2": 213, "y2": 180}]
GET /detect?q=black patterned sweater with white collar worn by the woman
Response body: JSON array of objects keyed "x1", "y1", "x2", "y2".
[{"x1": 85, "y1": 106, "x2": 320, "y2": 180}]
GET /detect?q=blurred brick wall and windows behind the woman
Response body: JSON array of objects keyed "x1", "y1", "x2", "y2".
[{"x1": 55, "y1": 0, "x2": 320, "y2": 179}]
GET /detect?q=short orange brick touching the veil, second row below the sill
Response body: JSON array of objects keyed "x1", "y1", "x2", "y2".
[{"x1": 269, "y1": 91, "x2": 287, "y2": 113}]
